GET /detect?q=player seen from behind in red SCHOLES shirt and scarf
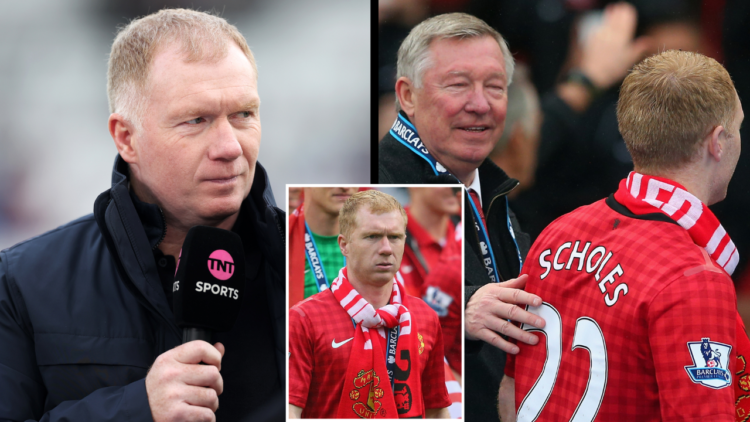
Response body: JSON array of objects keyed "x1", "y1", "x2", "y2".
[{"x1": 500, "y1": 50, "x2": 750, "y2": 422}]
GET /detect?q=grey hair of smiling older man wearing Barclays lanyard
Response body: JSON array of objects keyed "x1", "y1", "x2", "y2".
[{"x1": 396, "y1": 13, "x2": 515, "y2": 111}]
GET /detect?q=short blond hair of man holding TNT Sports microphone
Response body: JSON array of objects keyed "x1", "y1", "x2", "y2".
[{"x1": 107, "y1": 9, "x2": 258, "y2": 128}]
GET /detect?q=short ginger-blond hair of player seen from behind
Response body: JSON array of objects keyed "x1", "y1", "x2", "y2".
[{"x1": 617, "y1": 50, "x2": 737, "y2": 170}]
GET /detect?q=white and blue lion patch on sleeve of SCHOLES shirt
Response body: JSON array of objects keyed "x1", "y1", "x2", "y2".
[{"x1": 685, "y1": 337, "x2": 732, "y2": 390}]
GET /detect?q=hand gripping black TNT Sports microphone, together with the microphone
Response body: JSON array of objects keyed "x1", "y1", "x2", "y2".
[{"x1": 146, "y1": 226, "x2": 245, "y2": 422}]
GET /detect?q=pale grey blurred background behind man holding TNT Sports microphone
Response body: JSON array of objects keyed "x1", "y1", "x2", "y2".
[{"x1": 0, "y1": 0, "x2": 371, "y2": 249}]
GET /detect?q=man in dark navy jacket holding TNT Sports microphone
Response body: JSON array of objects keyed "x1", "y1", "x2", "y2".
[{"x1": 0, "y1": 9, "x2": 285, "y2": 422}]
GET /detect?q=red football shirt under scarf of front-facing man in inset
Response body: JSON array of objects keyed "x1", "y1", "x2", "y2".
[{"x1": 289, "y1": 290, "x2": 451, "y2": 418}]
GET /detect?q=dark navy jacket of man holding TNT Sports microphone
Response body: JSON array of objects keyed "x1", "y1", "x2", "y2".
[{"x1": 0, "y1": 156, "x2": 286, "y2": 421}]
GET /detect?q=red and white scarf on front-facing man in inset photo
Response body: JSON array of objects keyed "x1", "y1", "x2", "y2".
[{"x1": 330, "y1": 267, "x2": 424, "y2": 419}]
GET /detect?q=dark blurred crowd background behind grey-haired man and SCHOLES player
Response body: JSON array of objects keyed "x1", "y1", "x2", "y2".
[{"x1": 378, "y1": 0, "x2": 750, "y2": 294}]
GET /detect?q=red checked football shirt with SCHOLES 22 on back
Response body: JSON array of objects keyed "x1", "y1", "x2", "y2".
[{"x1": 506, "y1": 199, "x2": 737, "y2": 422}]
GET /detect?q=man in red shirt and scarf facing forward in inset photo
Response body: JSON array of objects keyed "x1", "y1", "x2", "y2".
[{"x1": 289, "y1": 190, "x2": 450, "y2": 419}]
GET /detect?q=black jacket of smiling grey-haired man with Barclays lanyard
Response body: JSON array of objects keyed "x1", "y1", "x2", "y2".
[{"x1": 378, "y1": 118, "x2": 530, "y2": 421}]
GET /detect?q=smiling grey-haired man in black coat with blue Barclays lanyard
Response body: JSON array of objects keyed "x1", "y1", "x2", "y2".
[{"x1": 378, "y1": 13, "x2": 544, "y2": 420}]
